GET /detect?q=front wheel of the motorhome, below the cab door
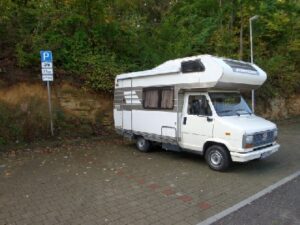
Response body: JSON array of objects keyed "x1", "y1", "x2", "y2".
[{"x1": 205, "y1": 145, "x2": 231, "y2": 171}]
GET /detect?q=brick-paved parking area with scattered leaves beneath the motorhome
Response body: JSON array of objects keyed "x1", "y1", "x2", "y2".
[{"x1": 0, "y1": 122, "x2": 300, "y2": 225}]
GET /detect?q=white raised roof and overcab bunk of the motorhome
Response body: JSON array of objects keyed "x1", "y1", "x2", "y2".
[{"x1": 116, "y1": 55, "x2": 267, "y2": 89}]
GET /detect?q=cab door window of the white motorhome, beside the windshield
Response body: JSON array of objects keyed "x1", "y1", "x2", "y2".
[{"x1": 188, "y1": 95, "x2": 212, "y2": 116}]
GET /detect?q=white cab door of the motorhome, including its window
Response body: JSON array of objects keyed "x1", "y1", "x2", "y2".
[{"x1": 181, "y1": 93, "x2": 214, "y2": 151}]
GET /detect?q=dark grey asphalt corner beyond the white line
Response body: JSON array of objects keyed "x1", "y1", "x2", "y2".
[{"x1": 212, "y1": 176, "x2": 300, "y2": 225}]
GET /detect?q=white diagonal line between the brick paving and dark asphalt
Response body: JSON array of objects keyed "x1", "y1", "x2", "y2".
[{"x1": 197, "y1": 170, "x2": 300, "y2": 225}]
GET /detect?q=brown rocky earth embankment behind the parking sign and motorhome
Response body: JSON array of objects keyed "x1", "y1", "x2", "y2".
[{"x1": 0, "y1": 82, "x2": 300, "y2": 145}]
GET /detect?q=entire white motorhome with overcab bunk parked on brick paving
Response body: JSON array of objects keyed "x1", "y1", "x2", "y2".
[{"x1": 114, "y1": 55, "x2": 279, "y2": 170}]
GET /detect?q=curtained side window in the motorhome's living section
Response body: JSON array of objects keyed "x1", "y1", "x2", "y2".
[{"x1": 143, "y1": 87, "x2": 174, "y2": 109}]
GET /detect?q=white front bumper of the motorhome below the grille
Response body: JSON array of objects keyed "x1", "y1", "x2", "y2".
[{"x1": 230, "y1": 143, "x2": 280, "y2": 162}]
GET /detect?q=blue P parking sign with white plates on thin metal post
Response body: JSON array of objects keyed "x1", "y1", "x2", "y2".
[{"x1": 40, "y1": 51, "x2": 54, "y2": 136}]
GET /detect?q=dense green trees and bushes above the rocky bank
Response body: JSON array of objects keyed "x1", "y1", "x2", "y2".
[{"x1": 0, "y1": 0, "x2": 300, "y2": 97}]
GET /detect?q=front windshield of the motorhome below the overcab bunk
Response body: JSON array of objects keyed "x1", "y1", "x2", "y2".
[{"x1": 209, "y1": 92, "x2": 252, "y2": 116}]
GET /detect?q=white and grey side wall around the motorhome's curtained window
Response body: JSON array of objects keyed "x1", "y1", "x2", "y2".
[{"x1": 114, "y1": 76, "x2": 178, "y2": 144}]
